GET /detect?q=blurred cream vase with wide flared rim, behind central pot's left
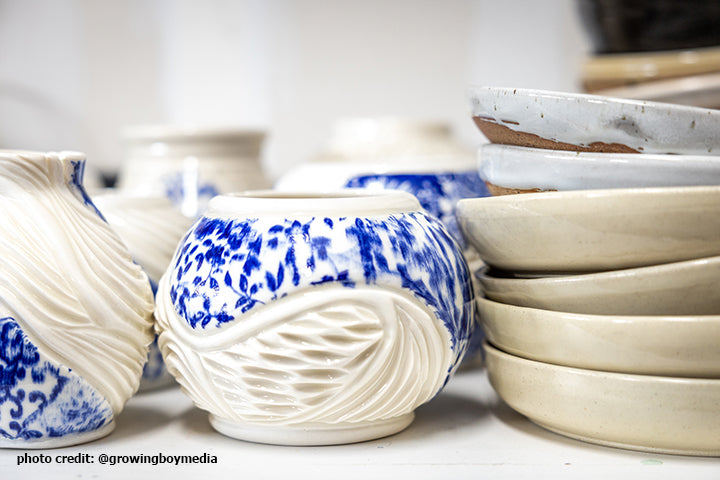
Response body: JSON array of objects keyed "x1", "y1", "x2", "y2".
[{"x1": 118, "y1": 126, "x2": 270, "y2": 218}]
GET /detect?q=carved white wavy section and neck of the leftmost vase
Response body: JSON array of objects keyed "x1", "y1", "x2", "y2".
[{"x1": 0, "y1": 155, "x2": 153, "y2": 413}]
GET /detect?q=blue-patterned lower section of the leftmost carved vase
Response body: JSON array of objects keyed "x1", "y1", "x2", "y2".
[{"x1": 0, "y1": 317, "x2": 113, "y2": 442}]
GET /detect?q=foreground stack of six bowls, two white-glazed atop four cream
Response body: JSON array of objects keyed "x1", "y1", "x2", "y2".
[{"x1": 457, "y1": 84, "x2": 720, "y2": 455}]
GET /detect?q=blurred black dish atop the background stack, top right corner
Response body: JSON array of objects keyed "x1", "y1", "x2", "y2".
[{"x1": 578, "y1": 0, "x2": 720, "y2": 54}]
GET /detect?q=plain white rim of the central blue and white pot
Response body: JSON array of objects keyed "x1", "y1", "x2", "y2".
[{"x1": 205, "y1": 189, "x2": 422, "y2": 218}]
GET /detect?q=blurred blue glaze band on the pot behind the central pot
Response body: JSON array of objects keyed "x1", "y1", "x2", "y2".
[{"x1": 345, "y1": 170, "x2": 490, "y2": 248}]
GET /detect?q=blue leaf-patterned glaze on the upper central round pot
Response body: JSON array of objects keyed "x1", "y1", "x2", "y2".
[{"x1": 170, "y1": 212, "x2": 474, "y2": 372}]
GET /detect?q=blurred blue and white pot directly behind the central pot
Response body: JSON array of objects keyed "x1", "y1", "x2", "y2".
[{"x1": 275, "y1": 124, "x2": 490, "y2": 366}]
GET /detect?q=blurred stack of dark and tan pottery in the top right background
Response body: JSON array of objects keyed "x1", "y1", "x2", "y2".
[{"x1": 578, "y1": 0, "x2": 720, "y2": 108}]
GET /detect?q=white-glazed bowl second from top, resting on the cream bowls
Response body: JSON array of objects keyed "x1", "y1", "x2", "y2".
[{"x1": 478, "y1": 143, "x2": 720, "y2": 195}]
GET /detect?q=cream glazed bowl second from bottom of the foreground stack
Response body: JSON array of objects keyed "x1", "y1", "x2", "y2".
[{"x1": 477, "y1": 297, "x2": 720, "y2": 378}]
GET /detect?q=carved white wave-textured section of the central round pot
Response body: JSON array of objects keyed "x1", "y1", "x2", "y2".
[{"x1": 158, "y1": 282, "x2": 453, "y2": 425}]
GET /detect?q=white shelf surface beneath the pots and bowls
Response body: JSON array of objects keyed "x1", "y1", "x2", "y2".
[{"x1": 0, "y1": 369, "x2": 720, "y2": 480}]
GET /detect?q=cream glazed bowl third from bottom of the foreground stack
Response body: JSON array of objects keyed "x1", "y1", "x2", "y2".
[{"x1": 475, "y1": 257, "x2": 720, "y2": 315}]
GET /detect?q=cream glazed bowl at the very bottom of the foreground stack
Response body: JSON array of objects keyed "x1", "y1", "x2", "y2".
[{"x1": 485, "y1": 344, "x2": 720, "y2": 456}]
